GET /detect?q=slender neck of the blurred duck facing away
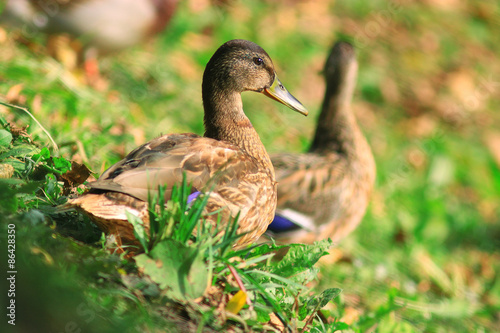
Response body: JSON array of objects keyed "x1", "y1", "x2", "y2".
[{"x1": 310, "y1": 70, "x2": 368, "y2": 159}]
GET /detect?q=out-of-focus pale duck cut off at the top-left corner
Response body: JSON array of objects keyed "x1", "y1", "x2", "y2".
[{"x1": 0, "y1": 0, "x2": 178, "y2": 82}]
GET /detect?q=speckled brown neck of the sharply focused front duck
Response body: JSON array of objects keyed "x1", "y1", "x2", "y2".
[{"x1": 203, "y1": 86, "x2": 272, "y2": 170}]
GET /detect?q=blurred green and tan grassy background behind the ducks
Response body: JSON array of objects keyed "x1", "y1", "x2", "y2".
[{"x1": 0, "y1": 0, "x2": 500, "y2": 332}]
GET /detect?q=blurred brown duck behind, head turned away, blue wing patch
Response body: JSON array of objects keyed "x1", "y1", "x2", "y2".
[{"x1": 268, "y1": 42, "x2": 375, "y2": 243}]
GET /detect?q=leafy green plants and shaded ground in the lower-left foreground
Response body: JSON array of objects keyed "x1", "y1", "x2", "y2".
[{"x1": 0, "y1": 126, "x2": 341, "y2": 332}]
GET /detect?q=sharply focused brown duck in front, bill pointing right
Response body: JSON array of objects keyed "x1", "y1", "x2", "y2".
[{"x1": 68, "y1": 40, "x2": 307, "y2": 247}]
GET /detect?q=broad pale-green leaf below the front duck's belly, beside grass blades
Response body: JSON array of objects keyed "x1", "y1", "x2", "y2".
[{"x1": 135, "y1": 239, "x2": 208, "y2": 300}]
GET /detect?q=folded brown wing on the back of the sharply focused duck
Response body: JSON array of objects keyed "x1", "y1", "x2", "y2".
[{"x1": 89, "y1": 133, "x2": 259, "y2": 201}]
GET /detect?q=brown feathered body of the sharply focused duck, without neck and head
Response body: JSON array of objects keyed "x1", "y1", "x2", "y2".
[{"x1": 64, "y1": 134, "x2": 276, "y2": 244}]
